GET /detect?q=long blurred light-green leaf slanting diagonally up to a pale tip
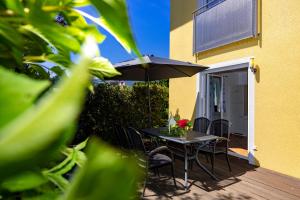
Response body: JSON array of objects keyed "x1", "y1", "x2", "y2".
[{"x1": 0, "y1": 49, "x2": 91, "y2": 180}]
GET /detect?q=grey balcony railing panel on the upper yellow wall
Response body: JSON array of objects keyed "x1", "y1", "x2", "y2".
[{"x1": 193, "y1": 0, "x2": 257, "y2": 53}]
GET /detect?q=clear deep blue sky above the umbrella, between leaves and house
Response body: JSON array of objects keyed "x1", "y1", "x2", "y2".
[{"x1": 78, "y1": 0, "x2": 170, "y2": 63}]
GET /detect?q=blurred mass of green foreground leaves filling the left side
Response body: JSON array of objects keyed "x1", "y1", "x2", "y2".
[{"x1": 0, "y1": 0, "x2": 140, "y2": 199}]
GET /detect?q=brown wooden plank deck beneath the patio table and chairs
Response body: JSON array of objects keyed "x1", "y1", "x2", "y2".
[{"x1": 143, "y1": 155, "x2": 300, "y2": 200}]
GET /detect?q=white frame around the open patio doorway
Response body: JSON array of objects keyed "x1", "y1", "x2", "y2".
[{"x1": 196, "y1": 57, "x2": 256, "y2": 164}]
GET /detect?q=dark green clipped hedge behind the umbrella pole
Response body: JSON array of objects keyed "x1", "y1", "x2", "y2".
[{"x1": 75, "y1": 83, "x2": 169, "y2": 142}]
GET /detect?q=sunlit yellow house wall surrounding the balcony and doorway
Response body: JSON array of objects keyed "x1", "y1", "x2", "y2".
[{"x1": 170, "y1": 0, "x2": 300, "y2": 178}]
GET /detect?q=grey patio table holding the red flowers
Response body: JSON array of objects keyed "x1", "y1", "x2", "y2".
[{"x1": 141, "y1": 127, "x2": 224, "y2": 190}]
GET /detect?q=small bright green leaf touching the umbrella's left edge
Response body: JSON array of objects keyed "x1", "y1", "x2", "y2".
[{"x1": 89, "y1": 57, "x2": 121, "y2": 79}]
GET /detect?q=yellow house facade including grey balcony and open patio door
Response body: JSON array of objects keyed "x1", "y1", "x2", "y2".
[{"x1": 169, "y1": 0, "x2": 300, "y2": 178}]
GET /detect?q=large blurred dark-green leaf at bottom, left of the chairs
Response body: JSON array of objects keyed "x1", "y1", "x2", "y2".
[{"x1": 63, "y1": 140, "x2": 140, "y2": 200}]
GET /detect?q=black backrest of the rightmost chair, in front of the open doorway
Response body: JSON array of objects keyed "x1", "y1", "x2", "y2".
[{"x1": 210, "y1": 119, "x2": 229, "y2": 139}]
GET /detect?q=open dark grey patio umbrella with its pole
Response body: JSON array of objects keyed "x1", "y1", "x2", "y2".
[{"x1": 110, "y1": 55, "x2": 208, "y2": 127}]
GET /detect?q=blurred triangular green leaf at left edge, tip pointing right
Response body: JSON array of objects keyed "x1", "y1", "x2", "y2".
[{"x1": 0, "y1": 67, "x2": 50, "y2": 129}]
